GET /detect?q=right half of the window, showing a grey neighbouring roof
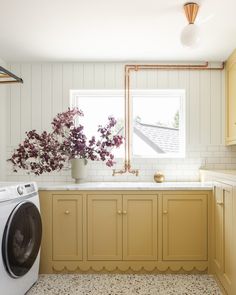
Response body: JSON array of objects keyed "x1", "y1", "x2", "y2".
[{"x1": 131, "y1": 90, "x2": 185, "y2": 158}]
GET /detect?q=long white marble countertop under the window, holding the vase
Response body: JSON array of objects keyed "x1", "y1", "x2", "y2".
[{"x1": 37, "y1": 182, "x2": 212, "y2": 191}]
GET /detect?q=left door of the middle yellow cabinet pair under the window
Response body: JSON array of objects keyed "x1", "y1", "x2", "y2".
[{"x1": 87, "y1": 195, "x2": 122, "y2": 260}]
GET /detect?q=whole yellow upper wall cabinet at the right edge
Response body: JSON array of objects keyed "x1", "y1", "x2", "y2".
[{"x1": 226, "y1": 51, "x2": 236, "y2": 145}]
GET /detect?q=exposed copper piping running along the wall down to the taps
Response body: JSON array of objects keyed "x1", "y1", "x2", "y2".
[{"x1": 112, "y1": 62, "x2": 225, "y2": 176}]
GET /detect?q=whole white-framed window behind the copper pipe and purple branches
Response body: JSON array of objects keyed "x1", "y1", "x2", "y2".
[{"x1": 71, "y1": 90, "x2": 185, "y2": 158}]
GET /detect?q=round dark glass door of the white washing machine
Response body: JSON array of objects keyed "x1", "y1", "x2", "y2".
[{"x1": 2, "y1": 202, "x2": 42, "y2": 278}]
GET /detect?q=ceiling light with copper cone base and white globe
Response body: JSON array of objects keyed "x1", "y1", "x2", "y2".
[{"x1": 180, "y1": 2, "x2": 200, "y2": 48}]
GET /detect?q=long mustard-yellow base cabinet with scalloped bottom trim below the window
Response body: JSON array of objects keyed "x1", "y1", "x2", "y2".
[{"x1": 40, "y1": 191, "x2": 211, "y2": 273}]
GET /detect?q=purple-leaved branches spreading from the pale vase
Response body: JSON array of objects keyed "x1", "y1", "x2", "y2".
[{"x1": 8, "y1": 108, "x2": 124, "y2": 175}]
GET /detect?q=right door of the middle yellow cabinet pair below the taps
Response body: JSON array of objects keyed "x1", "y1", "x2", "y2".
[{"x1": 123, "y1": 195, "x2": 157, "y2": 260}]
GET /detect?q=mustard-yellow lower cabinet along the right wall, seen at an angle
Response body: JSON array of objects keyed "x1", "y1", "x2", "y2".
[{"x1": 213, "y1": 183, "x2": 236, "y2": 294}]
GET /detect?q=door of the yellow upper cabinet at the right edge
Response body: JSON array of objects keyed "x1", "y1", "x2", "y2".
[{"x1": 227, "y1": 64, "x2": 236, "y2": 144}]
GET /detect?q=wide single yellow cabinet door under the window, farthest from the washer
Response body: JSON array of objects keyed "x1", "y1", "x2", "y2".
[{"x1": 163, "y1": 194, "x2": 208, "y2": 260}]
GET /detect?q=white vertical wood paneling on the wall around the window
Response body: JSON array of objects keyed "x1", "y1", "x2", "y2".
[{"x1": 7, "y1": 63, "x2": 224, "y2": 153}]
